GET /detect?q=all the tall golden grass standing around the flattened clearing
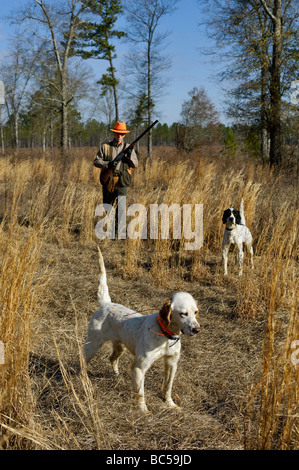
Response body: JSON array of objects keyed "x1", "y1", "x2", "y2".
[{"x1": 0, "y1": 150, "x2": 299, "y2": 449}]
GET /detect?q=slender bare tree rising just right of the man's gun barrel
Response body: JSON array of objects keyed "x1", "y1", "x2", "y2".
[{"x1": 124, "y1": 0, "x2": 177, "y2": 157}]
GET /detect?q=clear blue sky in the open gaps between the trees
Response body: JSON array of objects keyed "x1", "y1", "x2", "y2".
[{"x1": 0, "y1": 0, "x2": 230, "y2": 124}]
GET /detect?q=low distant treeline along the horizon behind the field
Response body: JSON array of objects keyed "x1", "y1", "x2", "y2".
[{"x1": 1, "y1": 103, "x2": 299, "y2": 165}]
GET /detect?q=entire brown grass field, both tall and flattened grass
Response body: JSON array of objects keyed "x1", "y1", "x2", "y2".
[{"x1": 0, "y1": 148, "x2": 299, "y2": 450}]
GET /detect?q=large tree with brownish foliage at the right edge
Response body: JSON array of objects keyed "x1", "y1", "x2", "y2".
[{"x1": 199, "y1": 0, "x2": 299, "y2": 165}]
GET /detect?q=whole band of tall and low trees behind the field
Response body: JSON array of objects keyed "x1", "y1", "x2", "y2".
[{"x1": 0, "y1": 0, "x2": 299, "y2": 165}]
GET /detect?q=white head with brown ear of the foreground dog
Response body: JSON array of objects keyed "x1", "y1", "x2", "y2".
[{"x1": 160, "y1": 292, "x2": 200, "y2": 336}]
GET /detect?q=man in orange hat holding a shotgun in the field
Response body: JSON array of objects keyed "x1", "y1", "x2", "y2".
[{"x1": 93, "y1": 121, "x2": 138, "y2": 237}]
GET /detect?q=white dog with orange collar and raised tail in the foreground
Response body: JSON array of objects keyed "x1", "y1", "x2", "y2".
[{"x1": 84, "y1": 249, "x2": 200, "y2": 412}]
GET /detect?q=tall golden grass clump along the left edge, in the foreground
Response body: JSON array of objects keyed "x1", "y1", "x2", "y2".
[{"x1": 0, "y1": 223, "x2": 46, "y2": 448}]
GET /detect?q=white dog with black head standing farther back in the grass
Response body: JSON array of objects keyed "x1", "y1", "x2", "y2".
[{"x1": 222, "y1": 199, "x2": 253, "y2": 276}]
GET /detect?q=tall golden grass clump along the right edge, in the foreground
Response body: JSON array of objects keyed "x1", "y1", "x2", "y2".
[{"x1": 240, "y1": 207, "x2": 299, "y2": 450}]
